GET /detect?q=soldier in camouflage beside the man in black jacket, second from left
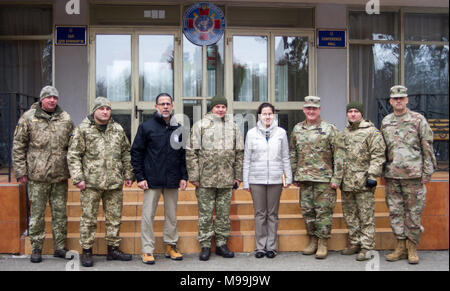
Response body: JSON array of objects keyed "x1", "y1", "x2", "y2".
[{"x1": 67, "y1": 97, "x2": 134, "y2": 267}]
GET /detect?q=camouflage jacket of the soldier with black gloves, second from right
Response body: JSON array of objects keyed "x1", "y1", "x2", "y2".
[{"x1": 338, "y1": 120, "x2": 386, "y2": 191}]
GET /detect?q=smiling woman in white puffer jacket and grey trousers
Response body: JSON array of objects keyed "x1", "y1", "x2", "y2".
[{"x1": 243, "y1": 103, "x2": 292, "y2": 258}]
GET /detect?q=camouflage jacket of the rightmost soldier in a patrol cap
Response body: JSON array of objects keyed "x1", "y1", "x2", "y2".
[{"x1": 381, "y1": 109, "x2": 436, "y2": 180}]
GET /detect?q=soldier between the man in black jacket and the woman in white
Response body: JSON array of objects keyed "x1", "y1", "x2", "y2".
[{"x1": 186, "y1": 96, "x2": 244, "y2": 261}]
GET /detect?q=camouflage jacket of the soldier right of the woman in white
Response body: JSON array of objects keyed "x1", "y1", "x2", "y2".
[{"x1": 289, "y1": 120, "x2": 342, "y2": 185}]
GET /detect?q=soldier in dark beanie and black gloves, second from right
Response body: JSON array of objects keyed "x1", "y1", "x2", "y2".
[{"x1": 338, "y1": 102, "x2": 386, "y2": 261}]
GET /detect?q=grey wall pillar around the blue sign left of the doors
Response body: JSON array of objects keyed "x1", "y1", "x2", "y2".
[{"x1": 53, "y1": 0, "x2": 89, "y2": 125}]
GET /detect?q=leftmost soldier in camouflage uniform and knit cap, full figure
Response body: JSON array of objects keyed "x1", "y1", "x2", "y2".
[{"x1": 12, "y1": 86, "x2": 74, "y2": 263}]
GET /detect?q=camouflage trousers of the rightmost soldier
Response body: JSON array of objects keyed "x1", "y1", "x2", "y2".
[{"x1": 386, "y1": 179, "x2": 427, "y2": 244}]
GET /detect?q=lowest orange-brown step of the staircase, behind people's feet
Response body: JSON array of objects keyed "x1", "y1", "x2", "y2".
[{"x1": 22, "y1": 228, "x2": 395, "y2": 255}]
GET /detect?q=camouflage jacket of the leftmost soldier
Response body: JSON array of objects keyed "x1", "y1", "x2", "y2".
[{"x1": 12, "y1": 102, "x2": 74, "y2": 183}]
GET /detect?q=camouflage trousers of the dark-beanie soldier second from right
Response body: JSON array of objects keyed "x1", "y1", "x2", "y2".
[{"x1": 341, "y1": 188, "x2": 375, "y2": 250}]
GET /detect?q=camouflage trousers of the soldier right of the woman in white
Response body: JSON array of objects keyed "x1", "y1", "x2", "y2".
[{"x1": 300, "y1": 182, "x2": 336, "y2": 239}]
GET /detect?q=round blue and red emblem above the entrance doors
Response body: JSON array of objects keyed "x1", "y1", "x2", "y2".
[{"x1": 183, "y1": 3, "x2": 225, "y2": 45}]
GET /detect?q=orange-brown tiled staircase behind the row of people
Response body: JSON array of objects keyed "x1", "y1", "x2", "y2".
[{"x1": 24, "y1": 183, "x2": 395, "y2": 254}]
